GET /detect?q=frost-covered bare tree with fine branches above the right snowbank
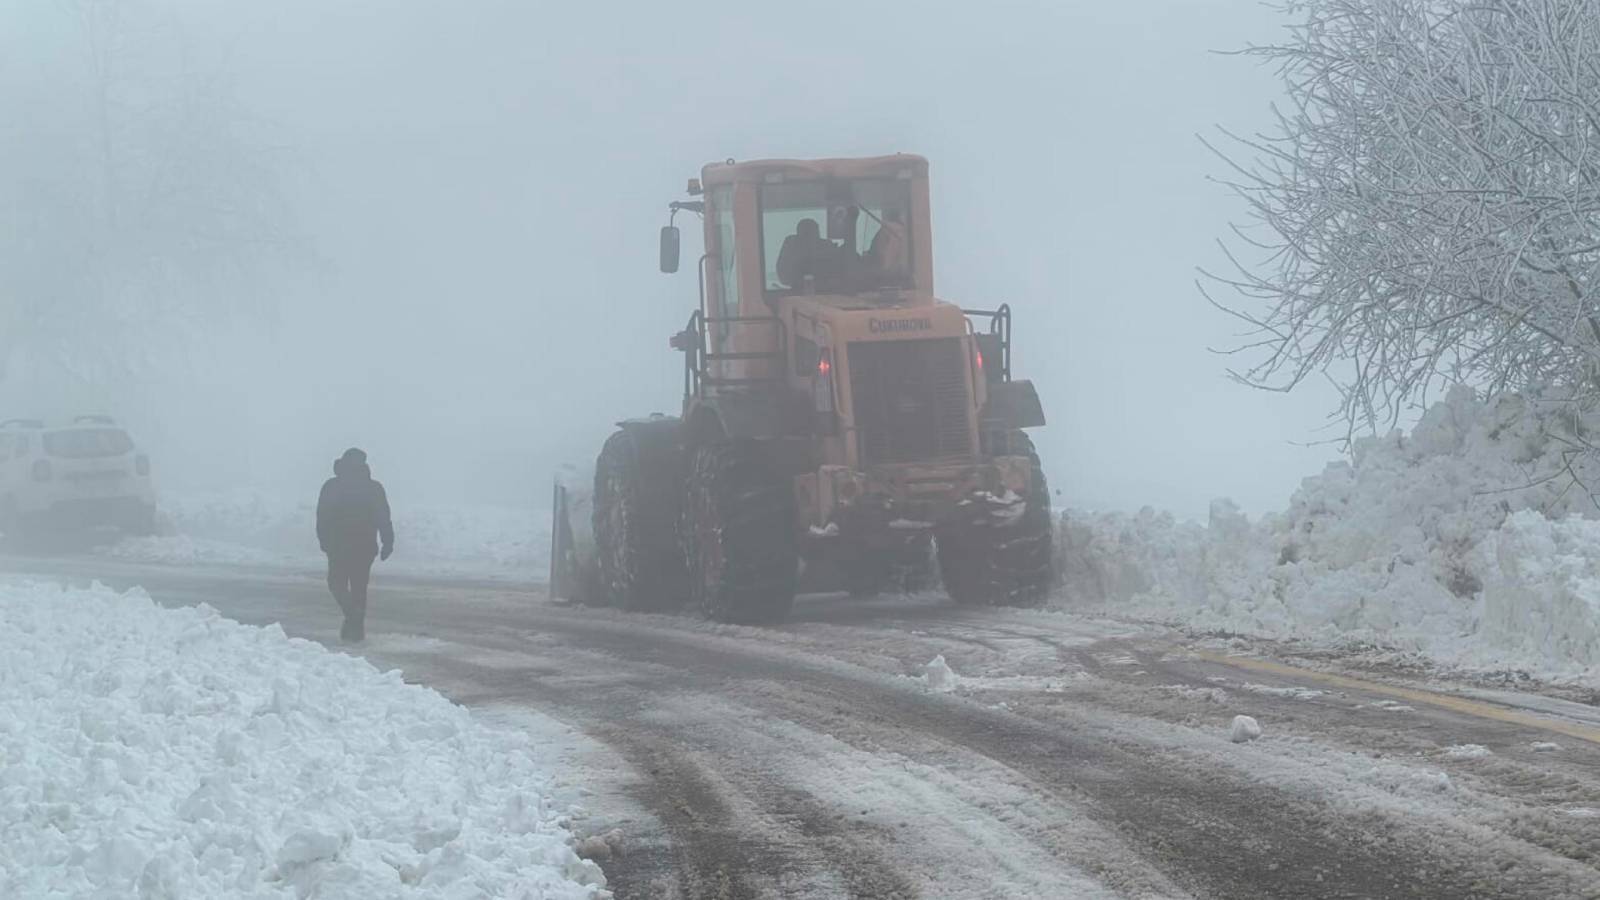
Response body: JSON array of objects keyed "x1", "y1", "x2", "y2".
[{"x1": 1202, "y1": 0, "x2": 1600, "y2": 428}]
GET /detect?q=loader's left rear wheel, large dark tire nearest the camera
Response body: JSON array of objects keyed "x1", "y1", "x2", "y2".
[{"x1": 683, "y1": 440, "x2": 800, "y2": 625}]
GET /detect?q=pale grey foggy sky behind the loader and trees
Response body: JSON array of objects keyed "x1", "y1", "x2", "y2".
[{"x1": 0, "y1": 0, "x2": 1334, "y2": 516}]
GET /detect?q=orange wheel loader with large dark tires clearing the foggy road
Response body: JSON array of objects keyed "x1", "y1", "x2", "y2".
[{"x1": 550, "y1": 154, "x2": 1053, "y2": 623}]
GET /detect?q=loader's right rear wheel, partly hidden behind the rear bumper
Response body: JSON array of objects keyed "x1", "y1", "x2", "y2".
[{"x1": 936, "y1": 431, "x2": 1053, "y2": 605}]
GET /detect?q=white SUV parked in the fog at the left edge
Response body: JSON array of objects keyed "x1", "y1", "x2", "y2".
[{"x1": 0, "y1": 416, "x2": 155, "y2": 536}]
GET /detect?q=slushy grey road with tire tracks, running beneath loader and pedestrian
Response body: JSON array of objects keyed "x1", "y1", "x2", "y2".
[{"x1": 12, "y1": 559, "x2": 1600, "y2": 898}]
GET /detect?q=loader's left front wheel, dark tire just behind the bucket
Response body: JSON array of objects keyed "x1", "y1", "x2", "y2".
[{"x1": 584, "y1": 429, "x2": 686, "y2": 612}]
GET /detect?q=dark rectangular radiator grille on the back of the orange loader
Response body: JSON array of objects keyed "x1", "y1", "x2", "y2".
[{"x1": 850, "y1": 338, "x2": 973, "y2": 466}]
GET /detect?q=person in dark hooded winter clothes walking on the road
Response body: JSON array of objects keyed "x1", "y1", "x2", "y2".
[{"x1": 317, "y1": 447, "x2": 395, "y2": 644}]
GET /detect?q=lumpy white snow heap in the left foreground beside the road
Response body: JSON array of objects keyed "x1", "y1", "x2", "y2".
[{"x1": 0, "y1": 585, "x2": 606, "y2": 900}]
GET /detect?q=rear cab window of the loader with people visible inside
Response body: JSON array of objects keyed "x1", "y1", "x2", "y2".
[{"x1": 762, "y1": 178, "x2": 912, "y2": 296}]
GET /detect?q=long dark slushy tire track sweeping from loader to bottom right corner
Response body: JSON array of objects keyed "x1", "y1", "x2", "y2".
[{"x1": 483, "y1": 605, "x2": 1590, "y2": 900}]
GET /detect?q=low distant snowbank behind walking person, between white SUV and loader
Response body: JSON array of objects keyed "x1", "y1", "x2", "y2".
[{"x1": 106, "y1": 490, "x2": 550, "y2": 578}]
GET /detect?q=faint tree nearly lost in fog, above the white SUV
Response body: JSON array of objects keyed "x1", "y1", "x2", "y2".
[{"x1": 0, "y1": 0, "x2": 307, "y2": 395}]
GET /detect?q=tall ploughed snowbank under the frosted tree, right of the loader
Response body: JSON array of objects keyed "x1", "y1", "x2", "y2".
[{"x1": 1059, "y1": 388, "x2": 1600, "y2": 681}]
